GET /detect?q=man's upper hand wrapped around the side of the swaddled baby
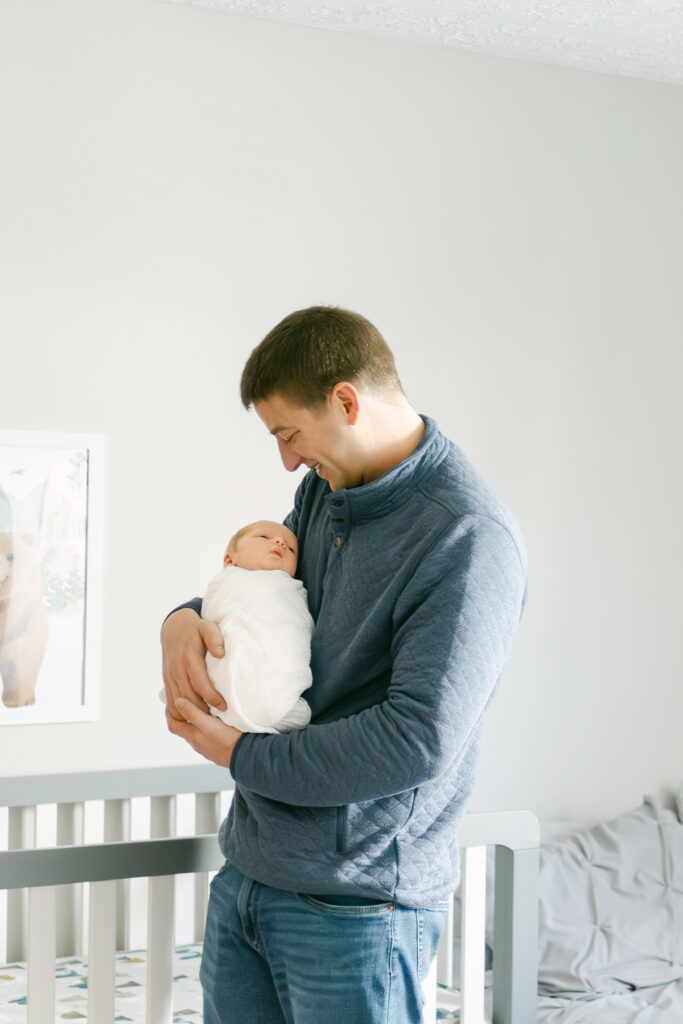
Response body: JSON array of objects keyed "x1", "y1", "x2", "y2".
[{"x1": 161, "y1": 608, "x2": 227, "y2": 731}]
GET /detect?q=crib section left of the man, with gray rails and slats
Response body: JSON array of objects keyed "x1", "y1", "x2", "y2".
[{"x1": 0, "y1": 765, "x2": 232, "y2": 1024}]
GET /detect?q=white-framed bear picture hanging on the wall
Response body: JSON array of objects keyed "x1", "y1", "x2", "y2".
[{"x1": 0, "y1": 430, "x2": 104, "y2": 726}]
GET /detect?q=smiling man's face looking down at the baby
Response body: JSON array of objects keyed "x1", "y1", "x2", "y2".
[{"x1": 255, "y1": 390, "x2": 362, "y2": 490}]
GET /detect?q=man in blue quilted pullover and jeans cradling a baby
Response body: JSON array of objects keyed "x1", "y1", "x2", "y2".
[{"x1": 163, "y1": 307, "x2": 526, "y2": 1024}]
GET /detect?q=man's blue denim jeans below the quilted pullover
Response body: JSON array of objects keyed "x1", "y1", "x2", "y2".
[{"x1": 200, "y1": 862, "x2": 445, "y2": 1024}]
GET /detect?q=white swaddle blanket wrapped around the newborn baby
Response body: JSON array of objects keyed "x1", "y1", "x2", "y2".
[{"x1": 202, "y1": 565, "x2": 313, "y2": 732}]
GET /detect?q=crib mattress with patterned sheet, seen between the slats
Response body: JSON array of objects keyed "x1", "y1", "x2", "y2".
[{"x1": 0, "y1": 943, "x2": 458, "y2": 1024}]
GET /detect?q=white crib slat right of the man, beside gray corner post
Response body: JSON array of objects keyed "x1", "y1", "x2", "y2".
[{"x1": 460, "y1": 846, "x2": 486, "y2": 1024}]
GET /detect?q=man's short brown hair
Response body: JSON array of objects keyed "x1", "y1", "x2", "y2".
[{"x1": 241, "y1": 306, "x2": 403, "y2": 409}]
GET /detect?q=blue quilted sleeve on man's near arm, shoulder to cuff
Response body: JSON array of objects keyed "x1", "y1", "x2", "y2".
[{"x1": 230, "y1": 515, "x2": 526, "y2": 807}]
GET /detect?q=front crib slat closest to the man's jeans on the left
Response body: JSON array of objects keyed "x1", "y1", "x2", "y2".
[{"x1": 146, "y1": 874, "x2": 175, "y2": 1024}]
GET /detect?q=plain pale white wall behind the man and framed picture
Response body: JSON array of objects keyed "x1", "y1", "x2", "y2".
[{"x1": 0, "y1": 0, "x2": 683, "y2": 817}]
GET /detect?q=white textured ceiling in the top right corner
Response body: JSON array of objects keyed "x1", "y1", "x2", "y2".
[{"x1": 162, "y1": 0, "x2": 683, "y2": 85}]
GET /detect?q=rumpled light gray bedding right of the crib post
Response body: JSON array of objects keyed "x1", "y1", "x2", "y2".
[{"x1": 539, "y1": 798, "x2": 683, "y2": 1024}]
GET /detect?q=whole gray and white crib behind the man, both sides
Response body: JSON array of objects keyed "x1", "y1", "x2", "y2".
[{"x1": 0, "y1": 764, "x2": 540, "y2": 1024}]
